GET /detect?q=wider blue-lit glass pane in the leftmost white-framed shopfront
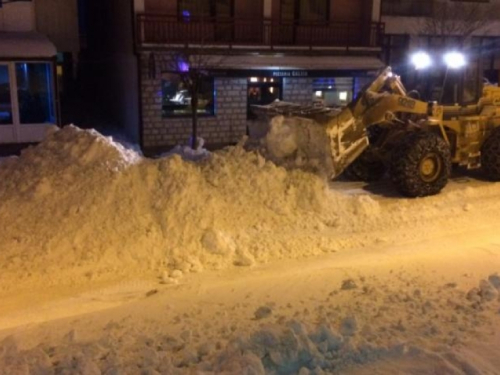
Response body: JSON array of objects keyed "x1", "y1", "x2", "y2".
[{"x1": 16, "y1": 63, "x2": 56, "y2": 124}]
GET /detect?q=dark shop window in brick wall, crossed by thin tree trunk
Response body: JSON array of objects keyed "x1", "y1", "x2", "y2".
[{"x1": 162, "y1": 73, "x2": 214, "y2": 117}]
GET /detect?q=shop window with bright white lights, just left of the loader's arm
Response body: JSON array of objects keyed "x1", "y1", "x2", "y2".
[{"x1": 313, "y1": 77, "x2": 354, "y2": 107}]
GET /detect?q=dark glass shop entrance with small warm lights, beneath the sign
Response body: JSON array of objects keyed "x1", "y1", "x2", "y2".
[{"x1": 247, "y1": 77, "x2": 283, "y2": 119}]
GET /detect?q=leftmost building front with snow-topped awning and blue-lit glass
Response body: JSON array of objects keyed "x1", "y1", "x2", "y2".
[{"x1": 0, "y1": 0, "x2": 79, "y2": 144}]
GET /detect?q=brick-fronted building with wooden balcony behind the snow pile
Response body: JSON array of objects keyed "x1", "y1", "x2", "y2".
[{"x1": 88, "y1": 0, "x2": 384, "y2": 151}]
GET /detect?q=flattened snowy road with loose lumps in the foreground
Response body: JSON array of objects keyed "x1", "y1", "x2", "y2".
[{"x1": 0, "y1": 210, "x2": 500, "y2": 374}]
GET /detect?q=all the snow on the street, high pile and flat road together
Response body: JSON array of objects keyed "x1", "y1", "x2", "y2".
[{"x1": 0, "y1": 126, "x2": 500, "y2": 375}]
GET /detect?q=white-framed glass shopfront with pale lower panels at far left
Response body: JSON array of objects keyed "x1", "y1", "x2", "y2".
[{"x1": 0, "y1": 61, "x2": 57, "y2": 143}]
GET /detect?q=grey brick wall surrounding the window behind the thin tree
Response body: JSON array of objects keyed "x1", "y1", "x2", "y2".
[{"x1": 141, "y1": 53, "x2": 247, "y2": 148}]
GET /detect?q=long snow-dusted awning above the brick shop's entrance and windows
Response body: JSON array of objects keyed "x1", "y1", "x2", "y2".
[{"x1": 197, "y1": 54, "x2": 385, "y2": 70}]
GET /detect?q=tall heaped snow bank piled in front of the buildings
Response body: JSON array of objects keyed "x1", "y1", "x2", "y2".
[{"x1": 0, "y1": 126, "x2": 498, "y2": 290}]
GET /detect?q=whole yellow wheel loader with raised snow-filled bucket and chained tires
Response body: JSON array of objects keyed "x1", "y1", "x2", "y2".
[{"x1": 256, "y1": 68, "x2": 500, "y2": 197}]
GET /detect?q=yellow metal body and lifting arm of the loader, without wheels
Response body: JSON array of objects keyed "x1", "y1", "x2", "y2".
[{"x1": 326, "y1": 68, "x2": 500, "y2": 177}]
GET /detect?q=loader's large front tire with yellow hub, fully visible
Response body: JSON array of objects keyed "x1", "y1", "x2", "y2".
[{"x1": 391, "y1": 131, "x2": 451, "y2": 197}]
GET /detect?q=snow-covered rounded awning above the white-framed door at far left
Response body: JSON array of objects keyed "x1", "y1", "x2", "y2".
[{"x1": 0, "y1": 32, "x2": 57, "y2": 59}]
